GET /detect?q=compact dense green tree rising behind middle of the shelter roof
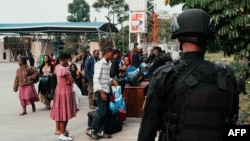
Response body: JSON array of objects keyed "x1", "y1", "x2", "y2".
[{"x1": 67, "y1": 0, "x2": 90, "y2": 22}]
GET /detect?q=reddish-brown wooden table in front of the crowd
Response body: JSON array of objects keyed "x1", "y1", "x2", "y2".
[{"x1": 123, "y1": 81, "x2": 149, "y2": 117}]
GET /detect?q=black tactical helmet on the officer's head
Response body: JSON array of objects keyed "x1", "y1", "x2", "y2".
[{"x1": 171, "y1": 9, "x2": 215, "y2": 39}]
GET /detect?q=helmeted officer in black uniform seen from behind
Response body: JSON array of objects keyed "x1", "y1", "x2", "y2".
[{"x1": 138, "y1": 9, "x2": 239, "y2": 141}]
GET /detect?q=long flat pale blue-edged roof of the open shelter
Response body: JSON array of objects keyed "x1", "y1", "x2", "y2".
[{"x1": 0, "y1": 22, "x2": 119, "y2": 34}]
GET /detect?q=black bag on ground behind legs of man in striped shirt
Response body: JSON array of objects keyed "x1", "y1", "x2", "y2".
[{"x1": 87, "y1": 111, "x2": 122, "y2": 134}]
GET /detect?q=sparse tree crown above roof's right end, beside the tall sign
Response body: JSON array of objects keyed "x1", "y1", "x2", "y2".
[{"x1": 92, "y1": 0, "x2": 129, "y2": 24}]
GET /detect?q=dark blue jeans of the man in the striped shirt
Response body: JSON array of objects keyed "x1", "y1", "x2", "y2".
[{"x1": 90, "y1": 91, "x2": 110, "y2": 132}]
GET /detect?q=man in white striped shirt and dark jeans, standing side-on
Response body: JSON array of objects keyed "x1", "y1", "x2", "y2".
[{"x1": 86, "y1": 48, "x2": 118, "y2": 140}]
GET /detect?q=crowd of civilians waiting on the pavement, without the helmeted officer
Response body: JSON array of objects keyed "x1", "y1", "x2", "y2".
[{"x1": 14, "y1": 43, "x2": 171, "y2": 140}]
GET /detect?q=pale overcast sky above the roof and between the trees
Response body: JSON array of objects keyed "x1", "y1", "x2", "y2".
[{"x1": 0, "y1": 0, "x2": 181, "y2": 23}]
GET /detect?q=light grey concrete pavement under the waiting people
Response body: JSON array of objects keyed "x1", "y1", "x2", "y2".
[{"x1": 0, "y1": 63, "x2": 141, "y2": 141}]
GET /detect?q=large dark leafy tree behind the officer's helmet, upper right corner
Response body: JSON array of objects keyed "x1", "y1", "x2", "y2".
[{"x1": 170, "y1": 0, "x2": 250, "y2": 58}]
